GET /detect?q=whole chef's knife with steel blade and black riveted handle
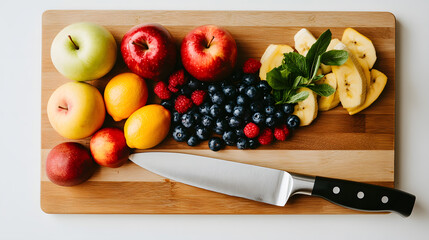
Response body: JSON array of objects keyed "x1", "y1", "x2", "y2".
[{"x1": 130, "y1": 152, "x2": 416, "y2": 216}]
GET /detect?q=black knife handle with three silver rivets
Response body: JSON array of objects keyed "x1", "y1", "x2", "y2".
[{"x1": 311, "y1": 177, "x2": 416, "y2": 217}]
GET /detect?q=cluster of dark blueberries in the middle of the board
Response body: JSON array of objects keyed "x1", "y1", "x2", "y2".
[{"x1": 161, "y1": 73, "x2": 300, "y2": 151}]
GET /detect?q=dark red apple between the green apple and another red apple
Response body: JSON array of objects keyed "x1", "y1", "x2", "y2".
[{"x1": 121, "y1": 23, "x2": 177, "y2": 80}]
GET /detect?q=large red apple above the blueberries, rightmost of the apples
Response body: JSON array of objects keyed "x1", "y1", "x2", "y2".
[{"x1": 181, "y1": 25, "x2": 237, "y2": 82}]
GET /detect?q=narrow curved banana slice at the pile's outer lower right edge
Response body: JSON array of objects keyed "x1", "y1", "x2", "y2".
[{"x1": 347, "y1": 69, "x2": 387, "y2": 115}]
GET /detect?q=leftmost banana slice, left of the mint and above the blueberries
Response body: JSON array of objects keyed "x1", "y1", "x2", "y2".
[{"x1": 259, "y1": 44, "x2": 293, "y2": 80}]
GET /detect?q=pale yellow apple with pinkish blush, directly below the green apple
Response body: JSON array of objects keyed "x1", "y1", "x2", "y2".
[{"x1": 47, "y1": 82, "x2": 106, "y2": 139}]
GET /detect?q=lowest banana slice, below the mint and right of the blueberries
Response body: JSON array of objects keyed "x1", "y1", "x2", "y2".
[{"x1": 293, "y1": 88, "x2": 318, "y2": 126}]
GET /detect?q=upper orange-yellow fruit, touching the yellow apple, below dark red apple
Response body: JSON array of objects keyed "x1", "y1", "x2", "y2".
[{"x1": 104, "y1": 73, "x2": 148, "y2": 121}]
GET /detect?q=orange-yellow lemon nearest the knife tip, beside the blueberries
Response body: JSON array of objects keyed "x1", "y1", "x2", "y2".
[{"x1": 124, "y1": 104, "x2": 171, "y2": 149}]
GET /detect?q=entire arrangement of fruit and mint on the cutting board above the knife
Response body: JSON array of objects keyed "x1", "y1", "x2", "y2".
[{"x1": 46, "y1": 22, "x2": 387, "y2": 186}]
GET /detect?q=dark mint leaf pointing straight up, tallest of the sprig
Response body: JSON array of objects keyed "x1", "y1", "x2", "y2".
[{"x1": 305, "y1": 29, "x2": 332, "y2": 78}]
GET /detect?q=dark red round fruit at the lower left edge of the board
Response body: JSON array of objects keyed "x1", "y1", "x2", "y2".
[{"x1": 46, "y1": 142, "x2": 97, "y2": 186}]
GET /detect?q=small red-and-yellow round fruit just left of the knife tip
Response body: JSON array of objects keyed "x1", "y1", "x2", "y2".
[{"x1": 89, "y1": 128, "x2": 130, "y2": 168}]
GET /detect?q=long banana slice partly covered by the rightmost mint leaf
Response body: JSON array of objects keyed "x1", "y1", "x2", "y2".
[{"x1": 332, "y1": 42, "x2": 367, "y2": 108}]
